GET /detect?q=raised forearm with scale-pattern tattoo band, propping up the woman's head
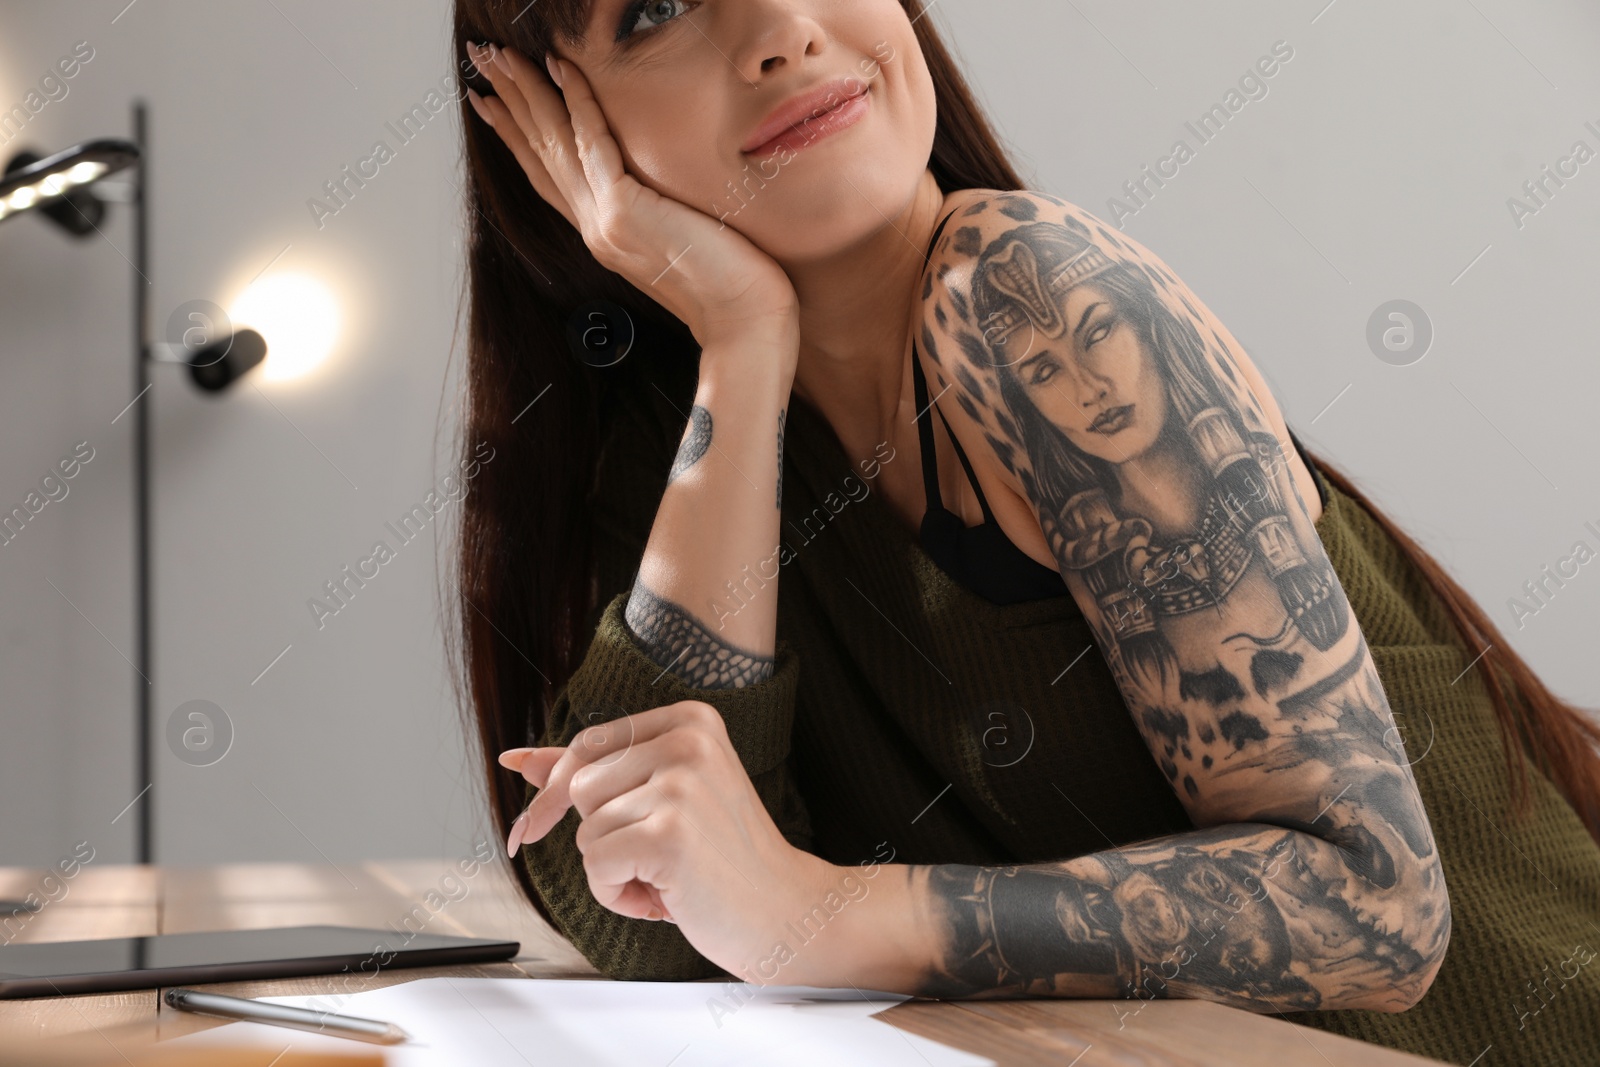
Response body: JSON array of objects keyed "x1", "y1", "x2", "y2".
[{"x1": 627, "y1": 331, "x2": 797, "y2": 688}]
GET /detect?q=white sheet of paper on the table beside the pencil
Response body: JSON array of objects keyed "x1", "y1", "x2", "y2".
[{"x1": 163, "y1": 977, "x2": 994, "y2": 1067}]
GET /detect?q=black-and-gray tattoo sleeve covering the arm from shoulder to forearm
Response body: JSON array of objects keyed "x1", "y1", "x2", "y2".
[{"x1": 912, "y1": 192, "x2": 1450, "y2": 1011}]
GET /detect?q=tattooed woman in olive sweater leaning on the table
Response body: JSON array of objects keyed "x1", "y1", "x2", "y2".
[{"x1": 444, "y1": 0, "x2": 1600, "y2": 1062}]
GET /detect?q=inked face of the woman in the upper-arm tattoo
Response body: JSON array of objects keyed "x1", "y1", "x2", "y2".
[{"x1": 1011, "y1": 282, "x2": 1166, "y2": 462}]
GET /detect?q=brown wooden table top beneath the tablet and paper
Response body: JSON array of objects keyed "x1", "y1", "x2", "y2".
[{"x1": 0, "y1": 851, "x2": 1438, "y2": 1067}]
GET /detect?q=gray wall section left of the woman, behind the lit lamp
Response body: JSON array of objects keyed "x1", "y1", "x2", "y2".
[{"x1": 0, "y1": 0, "x2": 486, "y2": 862}]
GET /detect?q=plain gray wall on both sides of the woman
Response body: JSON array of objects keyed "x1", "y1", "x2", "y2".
[{"x1": 0, "y1": 0, "x2": 1600, "y2": 864}]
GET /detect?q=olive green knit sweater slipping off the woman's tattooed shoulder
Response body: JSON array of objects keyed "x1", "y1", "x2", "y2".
[{"x1": 522, "y1": 369, "x2": 1600, "y2": 1067}]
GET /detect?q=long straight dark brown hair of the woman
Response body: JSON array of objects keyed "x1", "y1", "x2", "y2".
[{"x1": 446, "y1": 0, "x2": 1600, "y2": 912}]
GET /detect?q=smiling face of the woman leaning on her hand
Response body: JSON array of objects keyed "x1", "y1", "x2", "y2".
[{"x1": 555, "y1": 0, "x2": 936, "y2": 261}]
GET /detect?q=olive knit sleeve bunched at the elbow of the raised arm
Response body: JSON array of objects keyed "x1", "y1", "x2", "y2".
[{"x1": 520, "y1": 371, "x2": 811, "y2": 981}]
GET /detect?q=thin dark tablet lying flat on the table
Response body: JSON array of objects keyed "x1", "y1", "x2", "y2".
[{"x1": 0, "y1": 926, "x2": 522, "y2": 998}]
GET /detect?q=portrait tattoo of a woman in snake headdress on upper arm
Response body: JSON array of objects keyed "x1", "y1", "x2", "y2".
[{"x1": 973, "y1": 216, "x2": 1349, "y2": 700}]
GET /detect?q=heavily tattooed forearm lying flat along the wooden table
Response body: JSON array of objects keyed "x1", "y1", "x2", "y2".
[{"x1": 812, "y1": 822, "x2": 1450, "y2": 1011}]
